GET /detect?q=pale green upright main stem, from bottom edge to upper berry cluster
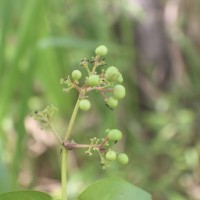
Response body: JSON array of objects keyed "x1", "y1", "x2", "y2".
[{"x1": 61, "y1": 93, "x2": 82, "y2": 200}]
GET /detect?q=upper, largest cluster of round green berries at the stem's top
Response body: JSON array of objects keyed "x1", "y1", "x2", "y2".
[{"x1": 61, "y1": 45, "x2": 126, "y2": 111}]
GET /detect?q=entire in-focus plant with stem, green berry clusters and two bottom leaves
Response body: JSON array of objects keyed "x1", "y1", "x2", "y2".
[{"x1": 0, "y1": 45, "x2": 151, "y2": 200}]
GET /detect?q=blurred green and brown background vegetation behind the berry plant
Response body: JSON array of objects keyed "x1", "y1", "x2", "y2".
[{"x1": 0, "y1": 0, "x2": 200, "y2": 200}]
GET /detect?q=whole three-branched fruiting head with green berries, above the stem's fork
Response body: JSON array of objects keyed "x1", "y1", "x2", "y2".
[{"x1": 34, "y1": 45, "x2": 129, "y2": 168}]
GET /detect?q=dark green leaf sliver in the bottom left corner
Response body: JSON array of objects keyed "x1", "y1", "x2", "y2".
[{"x1": 0, "y1": 191, "x2": 52, "y2": 200}]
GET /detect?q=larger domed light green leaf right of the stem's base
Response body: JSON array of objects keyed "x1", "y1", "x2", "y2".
[{"x1": 78, "y1": 177, "x2": 151, "y2": 200}]
